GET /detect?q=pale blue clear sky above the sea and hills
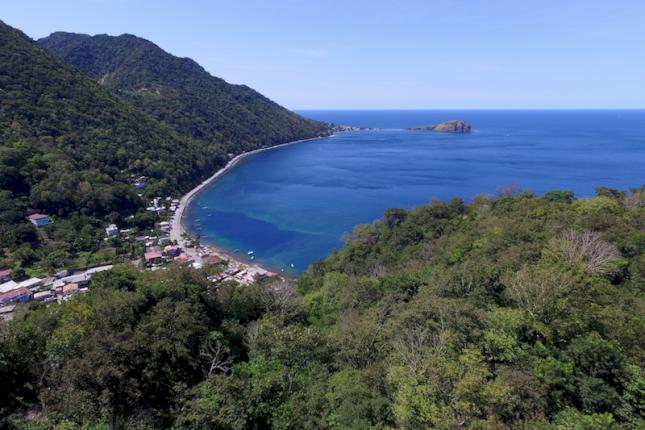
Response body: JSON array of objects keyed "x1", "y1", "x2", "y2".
[{"x1": 5, "y1": 0, "x2": 645, "y2": 109}]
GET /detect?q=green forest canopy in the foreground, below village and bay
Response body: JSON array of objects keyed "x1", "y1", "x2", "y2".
[{"x1": 0, "y1": 188, "x2": 645, "y2": 430}]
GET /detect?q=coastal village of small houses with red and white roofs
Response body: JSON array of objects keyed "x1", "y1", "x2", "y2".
[{"x1": 0, "y1": 186, "x2": 278, "y2": 320}]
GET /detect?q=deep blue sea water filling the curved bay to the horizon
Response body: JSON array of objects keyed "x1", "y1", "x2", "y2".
[{"x1": 186, "y1": 111, "x2": 645, "y2": 273}]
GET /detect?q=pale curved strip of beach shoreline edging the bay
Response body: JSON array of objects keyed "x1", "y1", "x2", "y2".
[{"x1": 170, "y1": 135, "x2": 333, "y2": 270}]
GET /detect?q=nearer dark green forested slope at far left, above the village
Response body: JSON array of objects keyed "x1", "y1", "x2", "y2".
[{"x1": 0, "y1": 19, "x2": 224, "y2": 207}]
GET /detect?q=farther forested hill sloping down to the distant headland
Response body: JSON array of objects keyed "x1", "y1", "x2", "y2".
[{"x1": 39, "y1": 32, "x2": 327, "y2": 151}]
